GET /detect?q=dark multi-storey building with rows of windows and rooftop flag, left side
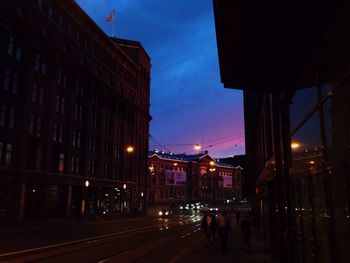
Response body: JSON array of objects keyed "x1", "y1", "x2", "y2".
[{"x1": 0, "y1": 0, "x2": 150, "y2": 222}]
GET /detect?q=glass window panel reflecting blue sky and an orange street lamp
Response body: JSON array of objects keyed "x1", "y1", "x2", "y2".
[{"x1": 290, "y1": 108, "x2": 331, "y2": 262}]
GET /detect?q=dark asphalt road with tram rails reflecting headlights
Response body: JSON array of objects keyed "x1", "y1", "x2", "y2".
[{"x1": 0, "y1": 213, "x2": 203, "y2": 263}]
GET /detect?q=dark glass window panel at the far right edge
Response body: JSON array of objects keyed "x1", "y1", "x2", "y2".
[{"x1": 323, "y1": 82, "x2": 350, "y2": 262}]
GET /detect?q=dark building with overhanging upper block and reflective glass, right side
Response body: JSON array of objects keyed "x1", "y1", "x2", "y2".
[{"x1": 214, "y1": 0, "x2": 350, "y2": 263}]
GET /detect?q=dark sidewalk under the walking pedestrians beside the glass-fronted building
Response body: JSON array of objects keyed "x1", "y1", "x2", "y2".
[{"x1": 178, "y1": 218, "x2": 273, "y2": 263}]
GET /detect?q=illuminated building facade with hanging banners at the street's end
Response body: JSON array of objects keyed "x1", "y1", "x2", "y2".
[{"x1": 149, "y1": 152, "x2": 242, "y2": 209}]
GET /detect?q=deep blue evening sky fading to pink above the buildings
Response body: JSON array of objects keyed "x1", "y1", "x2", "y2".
[{"x1": 77, "y1": 0, "x2": 245, "y2": 157}]
